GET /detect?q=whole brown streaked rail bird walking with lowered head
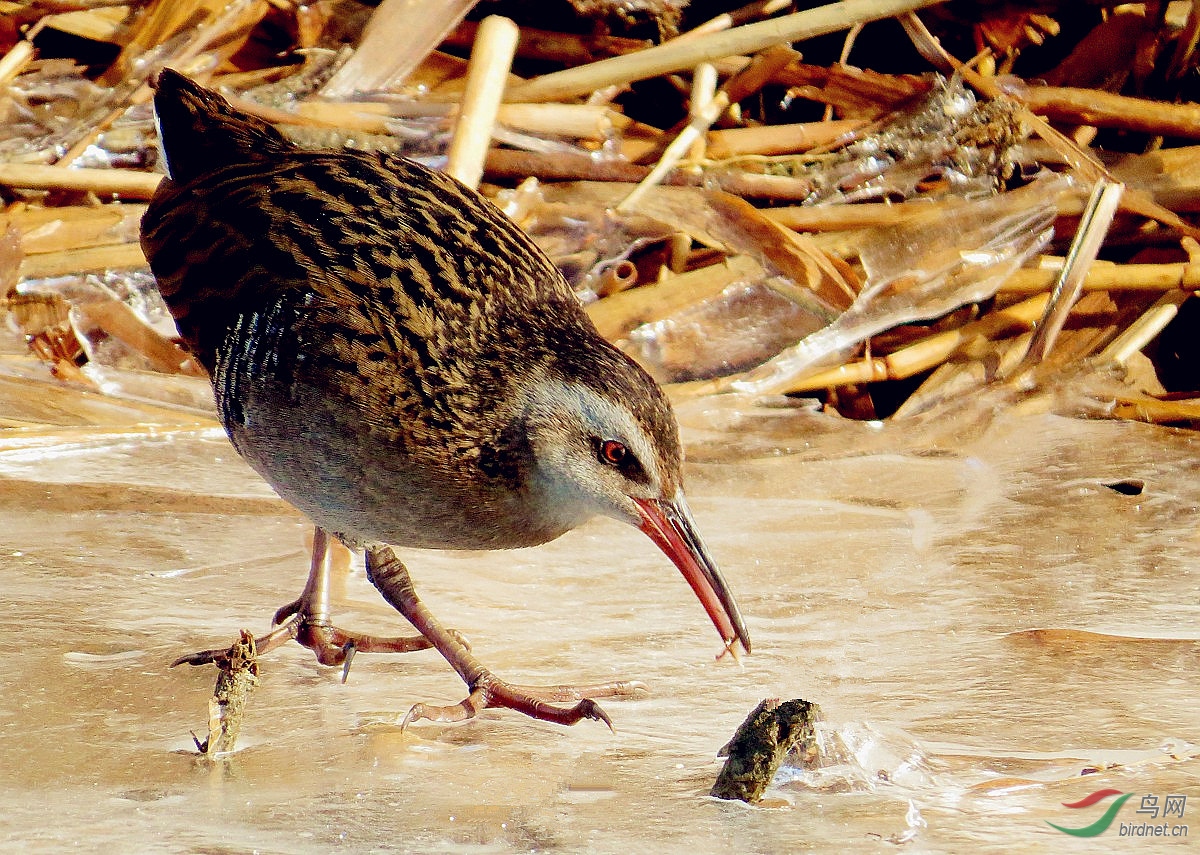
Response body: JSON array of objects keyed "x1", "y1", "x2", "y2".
[{"x1": 142, "y1": 70, "x2": 749, "y2": 722}]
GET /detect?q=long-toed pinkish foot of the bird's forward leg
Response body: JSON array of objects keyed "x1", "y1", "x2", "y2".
[{"x1": 400, "y1": 671, "x2": 648, "y2": 730}]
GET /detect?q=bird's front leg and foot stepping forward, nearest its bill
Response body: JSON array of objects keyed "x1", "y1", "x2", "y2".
[{"x1": 367, "y1": 546, "x2": 646, "y2": 730}]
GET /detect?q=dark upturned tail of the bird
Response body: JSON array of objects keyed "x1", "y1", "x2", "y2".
[{"x1": 154, "y1": 68, "x2": 292, "y2": 184}]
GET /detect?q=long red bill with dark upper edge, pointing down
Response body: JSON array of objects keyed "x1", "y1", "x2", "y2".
[{"x1": 634, "y1": 490, "x2": 750, "y2": 653}]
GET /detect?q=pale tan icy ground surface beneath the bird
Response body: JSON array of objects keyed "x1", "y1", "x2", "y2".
[{"x1": 0, "y1": 365, "x2": 1200, "y2": 853}]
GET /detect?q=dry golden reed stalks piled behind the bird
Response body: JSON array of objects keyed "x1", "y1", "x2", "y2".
[{"x1": 0, "y1": 0, "x2": 1200, "y2": 426}]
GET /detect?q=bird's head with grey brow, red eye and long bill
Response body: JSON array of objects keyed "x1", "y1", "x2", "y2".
[{"x1": 521, "y1": 353, "x2": 750, "y2": 656}]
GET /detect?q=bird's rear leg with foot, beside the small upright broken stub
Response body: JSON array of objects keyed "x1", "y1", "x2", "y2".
[{"x1": 172, "y1": 527, "x2": 446, "y2": 681}]
